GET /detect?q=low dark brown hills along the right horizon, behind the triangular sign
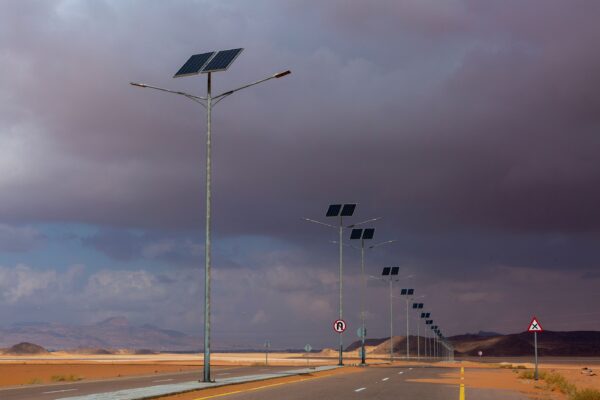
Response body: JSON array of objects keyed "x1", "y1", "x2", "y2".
[{"x1": 346, "y1": 331, "x2": 600, "y2": 357}]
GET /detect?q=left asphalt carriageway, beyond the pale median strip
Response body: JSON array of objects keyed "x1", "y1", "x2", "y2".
[{"x1": 0, "y1": 366, "x2": 290, "y2": 400}]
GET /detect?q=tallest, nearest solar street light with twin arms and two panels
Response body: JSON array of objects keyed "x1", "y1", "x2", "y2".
[{"x1": 130, "y1": 48, "x2": 291, "y2": 382}]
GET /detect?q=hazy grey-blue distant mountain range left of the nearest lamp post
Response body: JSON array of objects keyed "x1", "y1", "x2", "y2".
[{"x1": 0, "y1": 317, "x2": 202, "y2": 351}]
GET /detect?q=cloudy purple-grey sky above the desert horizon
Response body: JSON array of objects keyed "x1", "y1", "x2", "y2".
[{"x1": 0, "y1": 0, "x2": 600, "y2": 348}]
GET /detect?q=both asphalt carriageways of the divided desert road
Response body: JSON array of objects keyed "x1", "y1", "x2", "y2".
[{"x1": 0, "y1": 366, "x2": 526, "y2": 400}]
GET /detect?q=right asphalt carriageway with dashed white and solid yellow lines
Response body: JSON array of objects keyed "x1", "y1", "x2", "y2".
[{"x1": 203, "y1": 367, "x2": 527, "y2": 400}]
